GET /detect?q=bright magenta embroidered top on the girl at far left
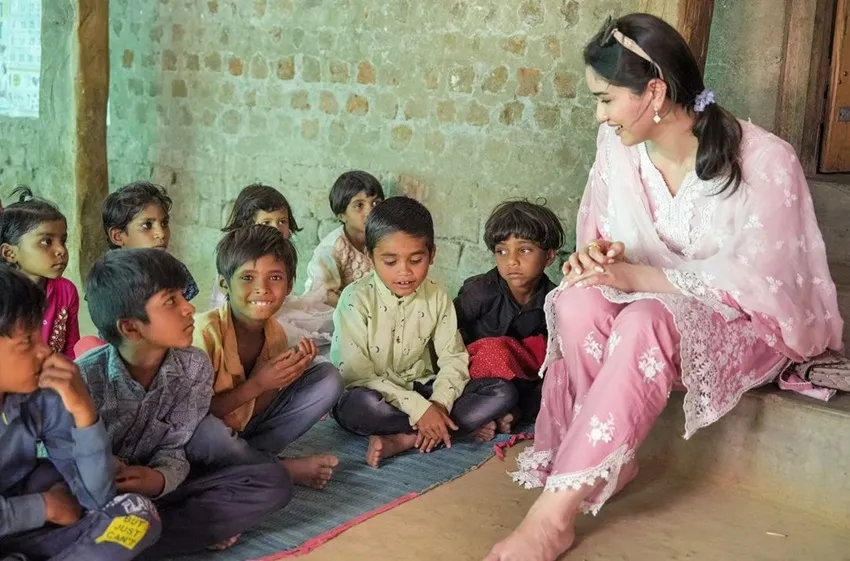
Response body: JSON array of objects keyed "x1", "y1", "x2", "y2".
[{"x1": 41, "y1": 277, "x2": 80, "y2": 359}]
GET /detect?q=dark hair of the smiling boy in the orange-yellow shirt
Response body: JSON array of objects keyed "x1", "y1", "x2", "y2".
[{"x1": 215, "y1": 224, "x2": 298, "y2": 286}]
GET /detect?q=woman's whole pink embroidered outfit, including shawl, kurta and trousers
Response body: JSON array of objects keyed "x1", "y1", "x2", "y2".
[{"x1": 513, "y1": 122, "x2": 843, "y2": 513}]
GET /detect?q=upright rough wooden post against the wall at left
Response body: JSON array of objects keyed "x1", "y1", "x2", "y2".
[{"x1": 74, "y1": 0, "x2": 109, "y2": 279}]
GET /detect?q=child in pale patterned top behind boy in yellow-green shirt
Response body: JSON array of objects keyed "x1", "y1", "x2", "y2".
[{"x1": 304, "y1": 170, "x2": 384, "y2": 307}]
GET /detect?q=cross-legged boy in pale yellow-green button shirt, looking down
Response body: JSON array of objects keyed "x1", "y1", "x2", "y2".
[{"x1": 331, "y1": 197, "x2": 517, "y2": 467}]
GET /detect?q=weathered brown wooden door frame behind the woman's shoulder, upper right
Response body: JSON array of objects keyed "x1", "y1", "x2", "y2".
[{"x1": 774, "y1": 0, "x2": 836, "y2": 177}]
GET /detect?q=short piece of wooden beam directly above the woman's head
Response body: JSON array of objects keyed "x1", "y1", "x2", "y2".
[{"x1": 640, "y1": 0, "x2": 714, "y2": 72}]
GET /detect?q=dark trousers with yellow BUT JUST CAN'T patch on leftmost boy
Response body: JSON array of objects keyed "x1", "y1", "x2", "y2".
[{"x1": 0, "y1": 462, "x2": 160, "y2": 561}]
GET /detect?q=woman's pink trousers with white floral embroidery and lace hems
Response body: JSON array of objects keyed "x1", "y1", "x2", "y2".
[{"x1": 512, "y1": 288, "x2": 680, "y2": 514}]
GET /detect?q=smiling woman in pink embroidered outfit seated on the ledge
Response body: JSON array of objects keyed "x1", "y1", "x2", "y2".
[{"x1": 486, "y1": 14, "x2": 842, "y2": 561}]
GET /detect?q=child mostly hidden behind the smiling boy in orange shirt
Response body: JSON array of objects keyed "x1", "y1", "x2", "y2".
[{"x1": 210, "y1": 183, "x2": 333, "y2": 345}]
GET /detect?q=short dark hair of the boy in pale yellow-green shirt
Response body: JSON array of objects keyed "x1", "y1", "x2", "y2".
[{"x1": 366, "y1": 197, "x2": 434, "y2": 253}]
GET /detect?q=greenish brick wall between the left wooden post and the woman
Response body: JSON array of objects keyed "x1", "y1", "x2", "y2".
[{"x1": 104, "y1": 0, "x2": 638, "y2": 302}]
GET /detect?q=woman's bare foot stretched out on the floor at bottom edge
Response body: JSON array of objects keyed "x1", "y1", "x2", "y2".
[{"x1": 484, "y1": 491, "x2": 582, "y2": 561}]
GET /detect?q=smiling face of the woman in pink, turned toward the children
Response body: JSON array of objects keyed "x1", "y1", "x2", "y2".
[{"x1": 585, "y1": 66, "x2": 661, "y2": 146}]
